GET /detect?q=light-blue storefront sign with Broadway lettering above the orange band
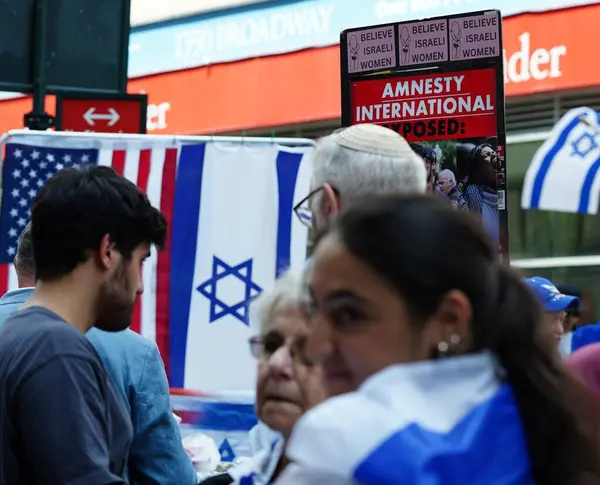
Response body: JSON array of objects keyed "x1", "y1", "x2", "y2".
[{"x1": 129, "y1": 0, "x2": 595, "y2": 77}]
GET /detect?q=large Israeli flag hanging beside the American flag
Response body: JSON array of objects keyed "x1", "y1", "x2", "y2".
[{"x1": 169, "y1": 142, "x2": 313, "y2": 397}]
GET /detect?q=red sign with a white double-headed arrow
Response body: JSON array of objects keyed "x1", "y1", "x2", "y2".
[{"x1": 56, "y1": 95, "x2": 147, "y2": 134}]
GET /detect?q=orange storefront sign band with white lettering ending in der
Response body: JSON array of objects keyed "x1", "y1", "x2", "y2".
[{"x1": 0, "y1": 4, "x2": 600, "y2": 138}]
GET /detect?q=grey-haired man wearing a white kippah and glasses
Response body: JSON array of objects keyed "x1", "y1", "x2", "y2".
[{"x1": 294, "y1": 124, "x2": 427, "y2": 231}]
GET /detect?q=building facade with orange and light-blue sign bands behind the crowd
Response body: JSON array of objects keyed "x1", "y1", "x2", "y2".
[{"x1": 0, "y1": 0, "x2": 600, "y2": 320}]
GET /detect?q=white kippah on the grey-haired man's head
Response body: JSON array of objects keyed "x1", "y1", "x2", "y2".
[{"x1": 333, "y1": 124, "x2": 414, "y2": 157}]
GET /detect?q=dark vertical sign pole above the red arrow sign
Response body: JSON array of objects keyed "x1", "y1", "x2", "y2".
[{"x1": 23, "y1": 0, "x2": 54, "y2": 131}]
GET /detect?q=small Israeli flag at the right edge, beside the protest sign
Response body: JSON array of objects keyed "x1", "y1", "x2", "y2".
[{"x1": 521, "y1": 108, "x2": 600, "y2": 214}]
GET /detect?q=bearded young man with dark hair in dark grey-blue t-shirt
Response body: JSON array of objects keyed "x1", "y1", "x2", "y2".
[{"x1": 0, "y1": 166, "x2": 166, "y2": 485}]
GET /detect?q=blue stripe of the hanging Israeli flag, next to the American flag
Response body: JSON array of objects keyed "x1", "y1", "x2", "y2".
[{"x1": 169, "y1": 144, "x2": 206, "y2": 387}]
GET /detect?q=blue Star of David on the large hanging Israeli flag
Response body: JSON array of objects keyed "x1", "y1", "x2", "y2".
[{"x1": 196, "y1": 256, "x2": 262, "y2": 325}]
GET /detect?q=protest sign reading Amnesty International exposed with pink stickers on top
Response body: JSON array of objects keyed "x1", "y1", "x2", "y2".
[{"x1": 341, "y1": 10, "x2": 508, "y2": 260}]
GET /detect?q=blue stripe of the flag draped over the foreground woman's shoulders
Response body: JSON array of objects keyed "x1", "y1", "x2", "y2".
[{"x1": 354, "y1": 385, "x2": 532, "y2": 485}]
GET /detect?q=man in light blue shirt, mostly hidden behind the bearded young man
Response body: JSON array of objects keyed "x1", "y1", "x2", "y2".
[{"x1": 0, "y1": 223, "x2": 198, "y2": 485}]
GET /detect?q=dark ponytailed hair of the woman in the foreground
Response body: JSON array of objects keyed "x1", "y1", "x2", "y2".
[{"x1": 331, "y1": 195, "x2": 600, "y2": 485}]
